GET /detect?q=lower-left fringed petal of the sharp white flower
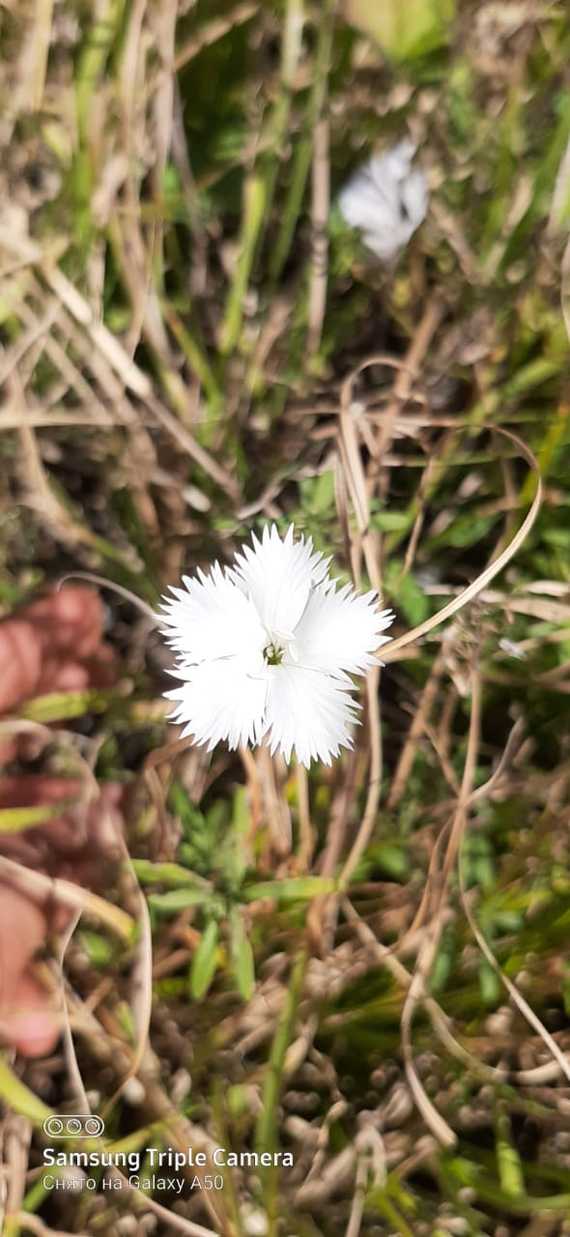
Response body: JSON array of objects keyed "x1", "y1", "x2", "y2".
[{"x1": 164, "y1": 657, "x2": 267, "y2": 751}]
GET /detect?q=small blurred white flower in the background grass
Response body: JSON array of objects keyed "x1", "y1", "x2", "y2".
[{"x1": 339, "y1": 139, "x2": 428, "y2": 262}]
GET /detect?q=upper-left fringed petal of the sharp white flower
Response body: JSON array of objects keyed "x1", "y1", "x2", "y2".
[{"x1": 158, "y1": 563, "x2": 266, "y2": 664}]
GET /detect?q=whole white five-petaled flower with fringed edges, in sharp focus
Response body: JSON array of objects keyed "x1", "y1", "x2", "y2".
[{"x1": 158, "y1": 524, "x2": 393, "y2": 766}]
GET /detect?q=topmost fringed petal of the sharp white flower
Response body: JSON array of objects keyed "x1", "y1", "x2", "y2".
[{"x1": 230, "y1": 524, "x2": 328, "y2": 637}]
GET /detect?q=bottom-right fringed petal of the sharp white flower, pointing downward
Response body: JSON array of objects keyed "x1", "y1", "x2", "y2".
[{"x1": 266, "y1": 662, "x2": 359, "y2": 767}]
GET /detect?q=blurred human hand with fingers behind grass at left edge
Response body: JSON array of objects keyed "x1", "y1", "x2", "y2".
[{"x1": 0, "y1": 585, "x2": 121, "y2": 1056}]
